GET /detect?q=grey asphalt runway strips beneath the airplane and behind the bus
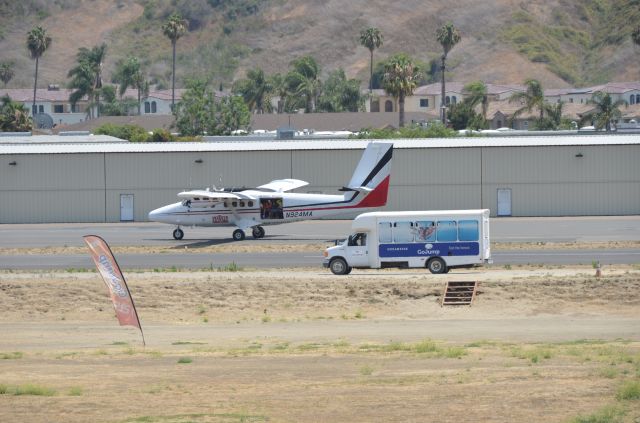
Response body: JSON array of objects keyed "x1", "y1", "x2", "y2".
[{"x1": 0, "y1": 216, "x2": 640, "y2": 270}]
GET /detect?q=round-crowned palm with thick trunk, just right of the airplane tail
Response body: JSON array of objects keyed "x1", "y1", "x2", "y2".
[{"x1": 382, "y1": 53, "x2": 421, "y2": 128}]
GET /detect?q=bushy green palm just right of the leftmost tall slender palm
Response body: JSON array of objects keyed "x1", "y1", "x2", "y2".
[{"x1": 67, "y1": 43, "x2": 107, "y2": 117}]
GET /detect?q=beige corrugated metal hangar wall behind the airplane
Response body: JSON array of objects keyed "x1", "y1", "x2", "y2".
[{"x1": 0, "y1": 141, "x2": 640, "y2": 223}]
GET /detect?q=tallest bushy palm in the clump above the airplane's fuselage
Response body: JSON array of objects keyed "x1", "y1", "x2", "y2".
[{"x1": 286, "y1": 56, "x2": 322, "y2": 113}]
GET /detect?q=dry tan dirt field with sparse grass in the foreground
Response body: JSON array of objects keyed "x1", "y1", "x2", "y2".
[{"x1": 0, "y1": 266, "x2": 640, "y2": 422}]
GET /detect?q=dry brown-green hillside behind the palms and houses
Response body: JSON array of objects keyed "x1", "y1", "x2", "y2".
[{"x1": 0, "y1": 0, "x2": 640, "y2": 87}]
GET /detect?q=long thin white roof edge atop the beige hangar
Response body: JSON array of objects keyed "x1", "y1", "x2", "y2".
[{"x1": 0, "y1": 135, "x2": 640, "y2": 154}]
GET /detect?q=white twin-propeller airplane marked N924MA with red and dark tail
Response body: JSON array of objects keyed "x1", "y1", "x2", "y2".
[{"x1": 149, "y1": 142, "x2": 393, "y2": 241}]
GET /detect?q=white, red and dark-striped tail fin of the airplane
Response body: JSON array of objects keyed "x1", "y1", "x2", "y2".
[{"x1": 341, "y1": 142, "x2": 393, "y2": 207}]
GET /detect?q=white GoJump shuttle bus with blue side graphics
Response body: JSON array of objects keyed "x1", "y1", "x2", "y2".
[{"x1": 323, "y1": 209, "x2": 492, "y2": 275}]
